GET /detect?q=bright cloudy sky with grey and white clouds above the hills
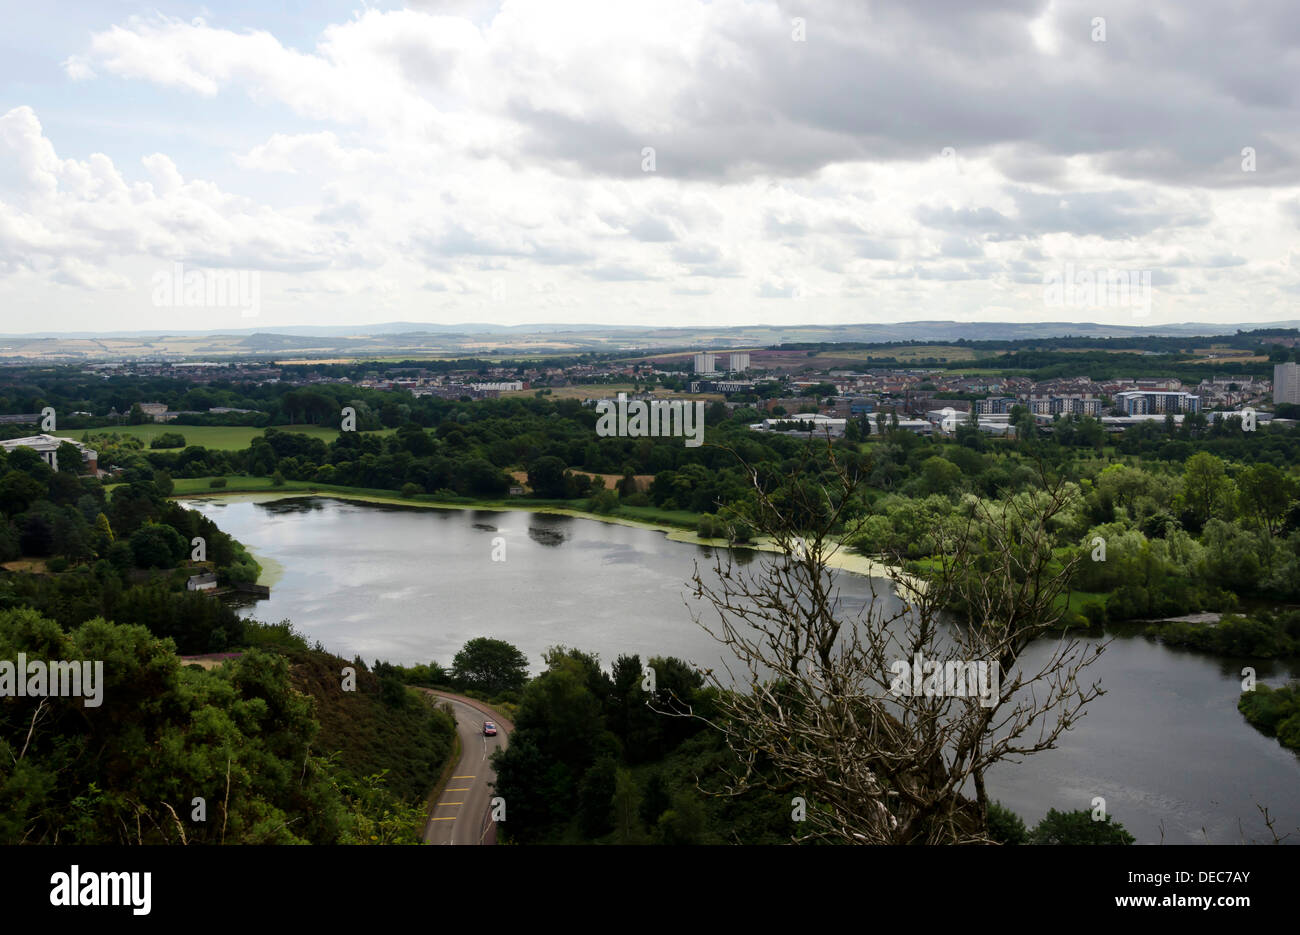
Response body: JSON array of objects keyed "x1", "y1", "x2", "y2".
[{"x1": 0, "y1": 0, "x2": 1300, "y2": 333}]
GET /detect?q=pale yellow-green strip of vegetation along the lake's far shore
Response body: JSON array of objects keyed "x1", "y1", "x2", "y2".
[{"x1": 169, "y1": 490, "x2": 920, "y2": 586}]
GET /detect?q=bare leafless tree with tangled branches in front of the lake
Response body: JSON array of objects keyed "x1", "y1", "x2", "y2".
[{"x1": 670, "y1": 443, "x2": 1104, "y2": 844}]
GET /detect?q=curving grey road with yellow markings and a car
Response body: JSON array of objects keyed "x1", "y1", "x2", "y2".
[{"x1": 424, "y1": 692, "x2": 510, "y2": 844}]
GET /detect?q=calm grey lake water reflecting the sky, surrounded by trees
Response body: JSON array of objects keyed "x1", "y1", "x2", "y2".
[{"x1": 186, "y1": 497, "x2": 1300, "y2": 844}]
